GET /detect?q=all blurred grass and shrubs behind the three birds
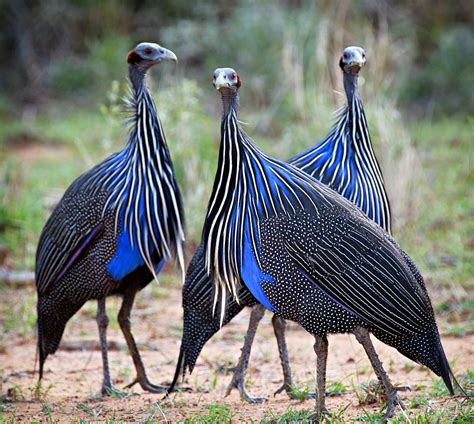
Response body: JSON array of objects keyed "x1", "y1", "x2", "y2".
[{"x1": 0, "y1": 0, "x2": 474, "y2": 312}]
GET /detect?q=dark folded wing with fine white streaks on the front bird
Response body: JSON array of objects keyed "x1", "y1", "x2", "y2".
[{"x1": 285, "y1": 210, "x2": 431, "y2": 335}]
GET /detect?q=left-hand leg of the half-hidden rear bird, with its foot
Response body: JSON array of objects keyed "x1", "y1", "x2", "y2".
[{"x1": 225, "y1": 305, "x2": 267, "y2": 403}]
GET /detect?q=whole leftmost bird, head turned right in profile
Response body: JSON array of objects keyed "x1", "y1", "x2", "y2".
[{"x1": 35, "y1": 42, "x2": 184, "y2": 395}]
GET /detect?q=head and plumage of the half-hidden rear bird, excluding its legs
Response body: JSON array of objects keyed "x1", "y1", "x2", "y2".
[{"x1": 171, "y1": 47, "x2": 391, "y2": 388}]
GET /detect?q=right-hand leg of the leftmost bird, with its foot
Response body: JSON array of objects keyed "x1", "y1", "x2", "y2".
[{"x1": 118, "y1": 288, "x2": 167, "y2": 393}]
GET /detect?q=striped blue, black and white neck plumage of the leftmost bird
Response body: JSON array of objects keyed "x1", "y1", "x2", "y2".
[{"x1": 104, "y1": 67, "x2": 184, "y2": 275}]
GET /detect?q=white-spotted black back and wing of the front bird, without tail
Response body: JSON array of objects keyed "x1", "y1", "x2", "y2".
[{"x1": 260, "y1": 185, "x2": 433, "y2": 342}]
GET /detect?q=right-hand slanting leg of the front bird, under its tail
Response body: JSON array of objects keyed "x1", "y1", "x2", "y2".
[{"x1": 354, "y1": 327, "x2": 409, "y2": 420}]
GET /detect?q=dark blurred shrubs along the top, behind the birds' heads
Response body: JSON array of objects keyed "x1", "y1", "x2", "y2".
[{"x1": 0, "y1": 0, "x2": 474, "y2": 116}]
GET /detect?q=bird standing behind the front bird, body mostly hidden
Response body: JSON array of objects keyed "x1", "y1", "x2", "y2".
[{"x1": 167, "y1": 46, "x2": 391, "y2": 403}]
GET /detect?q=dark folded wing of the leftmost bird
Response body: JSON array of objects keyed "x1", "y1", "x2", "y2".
[{"x1": 36, "y1": 186, "x2": 104, "y2": 294}]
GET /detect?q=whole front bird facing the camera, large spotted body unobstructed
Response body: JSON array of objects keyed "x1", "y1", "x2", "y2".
[{"x1": 179, "y1": 68, "x2": 454, "y2": 419}]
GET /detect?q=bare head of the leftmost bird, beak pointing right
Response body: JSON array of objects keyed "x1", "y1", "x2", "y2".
[{"x1": 127, "y1": 42, "x2": 178, "y2": 89}]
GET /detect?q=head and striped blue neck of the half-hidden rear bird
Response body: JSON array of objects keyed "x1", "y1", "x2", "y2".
[{"x1": 288, "y1": 47, "x2": 392, "y2": 233}]
